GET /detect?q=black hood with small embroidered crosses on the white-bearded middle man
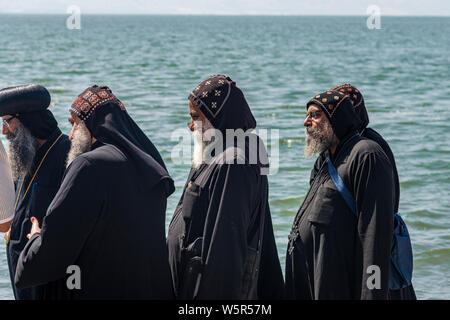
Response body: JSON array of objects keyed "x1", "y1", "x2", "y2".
[{"x1": 189, "y1": 75, "x2": 256, "y2": 132}]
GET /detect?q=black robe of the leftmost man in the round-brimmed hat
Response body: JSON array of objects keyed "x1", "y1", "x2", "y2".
[{"x1": 7, "y1": 129, "x2": 70, "y2": 300}]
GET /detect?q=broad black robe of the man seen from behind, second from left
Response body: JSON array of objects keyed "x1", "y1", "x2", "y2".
[{"x1": 15, "y1": 141, "x2": 173, "y2": 299}]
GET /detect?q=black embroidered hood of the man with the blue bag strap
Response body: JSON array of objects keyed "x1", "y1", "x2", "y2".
[{"x1": 306, "y1": 90, "x2": 361, "y2": 140}]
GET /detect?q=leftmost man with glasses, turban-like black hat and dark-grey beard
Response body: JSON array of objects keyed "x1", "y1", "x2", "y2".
[{"x1": 0, "y1": 84, "x2": 70, "y2": 300}]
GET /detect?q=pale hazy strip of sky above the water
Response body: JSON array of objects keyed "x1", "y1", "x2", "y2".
[{"x1": 0, "y1": 0, "x2": 450, "y2": 16}]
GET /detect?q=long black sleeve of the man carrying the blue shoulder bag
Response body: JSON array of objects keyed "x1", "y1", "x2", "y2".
[{"x1": 353, "y1": 153, "x2": 394, "y2": 300}]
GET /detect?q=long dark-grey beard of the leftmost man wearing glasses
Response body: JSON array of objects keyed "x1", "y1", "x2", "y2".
[{"x1": 6, "y1": 122, "x2": 38, "y2": 180}]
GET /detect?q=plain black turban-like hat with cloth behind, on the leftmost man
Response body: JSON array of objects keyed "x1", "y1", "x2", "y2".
[{"x1": 0, "y1": 84, "x2": 58, "y2": 140}]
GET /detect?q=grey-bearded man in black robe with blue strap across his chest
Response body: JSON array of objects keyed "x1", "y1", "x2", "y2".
[{"x1": 286, "y1": 90, "x2": 395, "y2": 299}]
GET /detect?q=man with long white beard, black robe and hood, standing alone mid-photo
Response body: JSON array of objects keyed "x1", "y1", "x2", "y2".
[{"x1": 167, "y1": 75, "x2": 283, "y2": 299}]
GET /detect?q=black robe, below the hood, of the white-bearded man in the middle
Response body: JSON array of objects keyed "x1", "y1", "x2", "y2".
[{"x1": 167, "y1": 149, "x2": 283, "y2": 299}]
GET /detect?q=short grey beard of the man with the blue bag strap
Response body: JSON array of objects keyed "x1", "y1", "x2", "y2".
[{"x1": 304, "y1": 122, "x2": 337, "y2": 158}]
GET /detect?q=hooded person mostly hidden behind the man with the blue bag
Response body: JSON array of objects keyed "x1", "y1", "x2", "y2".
[{"x1": 310, "y1": 83, "x2": 416, "y2": 300}]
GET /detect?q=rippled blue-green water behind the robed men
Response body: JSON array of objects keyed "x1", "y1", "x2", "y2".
[{"x1": 0, "y1": 15, "x2": 450, "y2": 299}]
